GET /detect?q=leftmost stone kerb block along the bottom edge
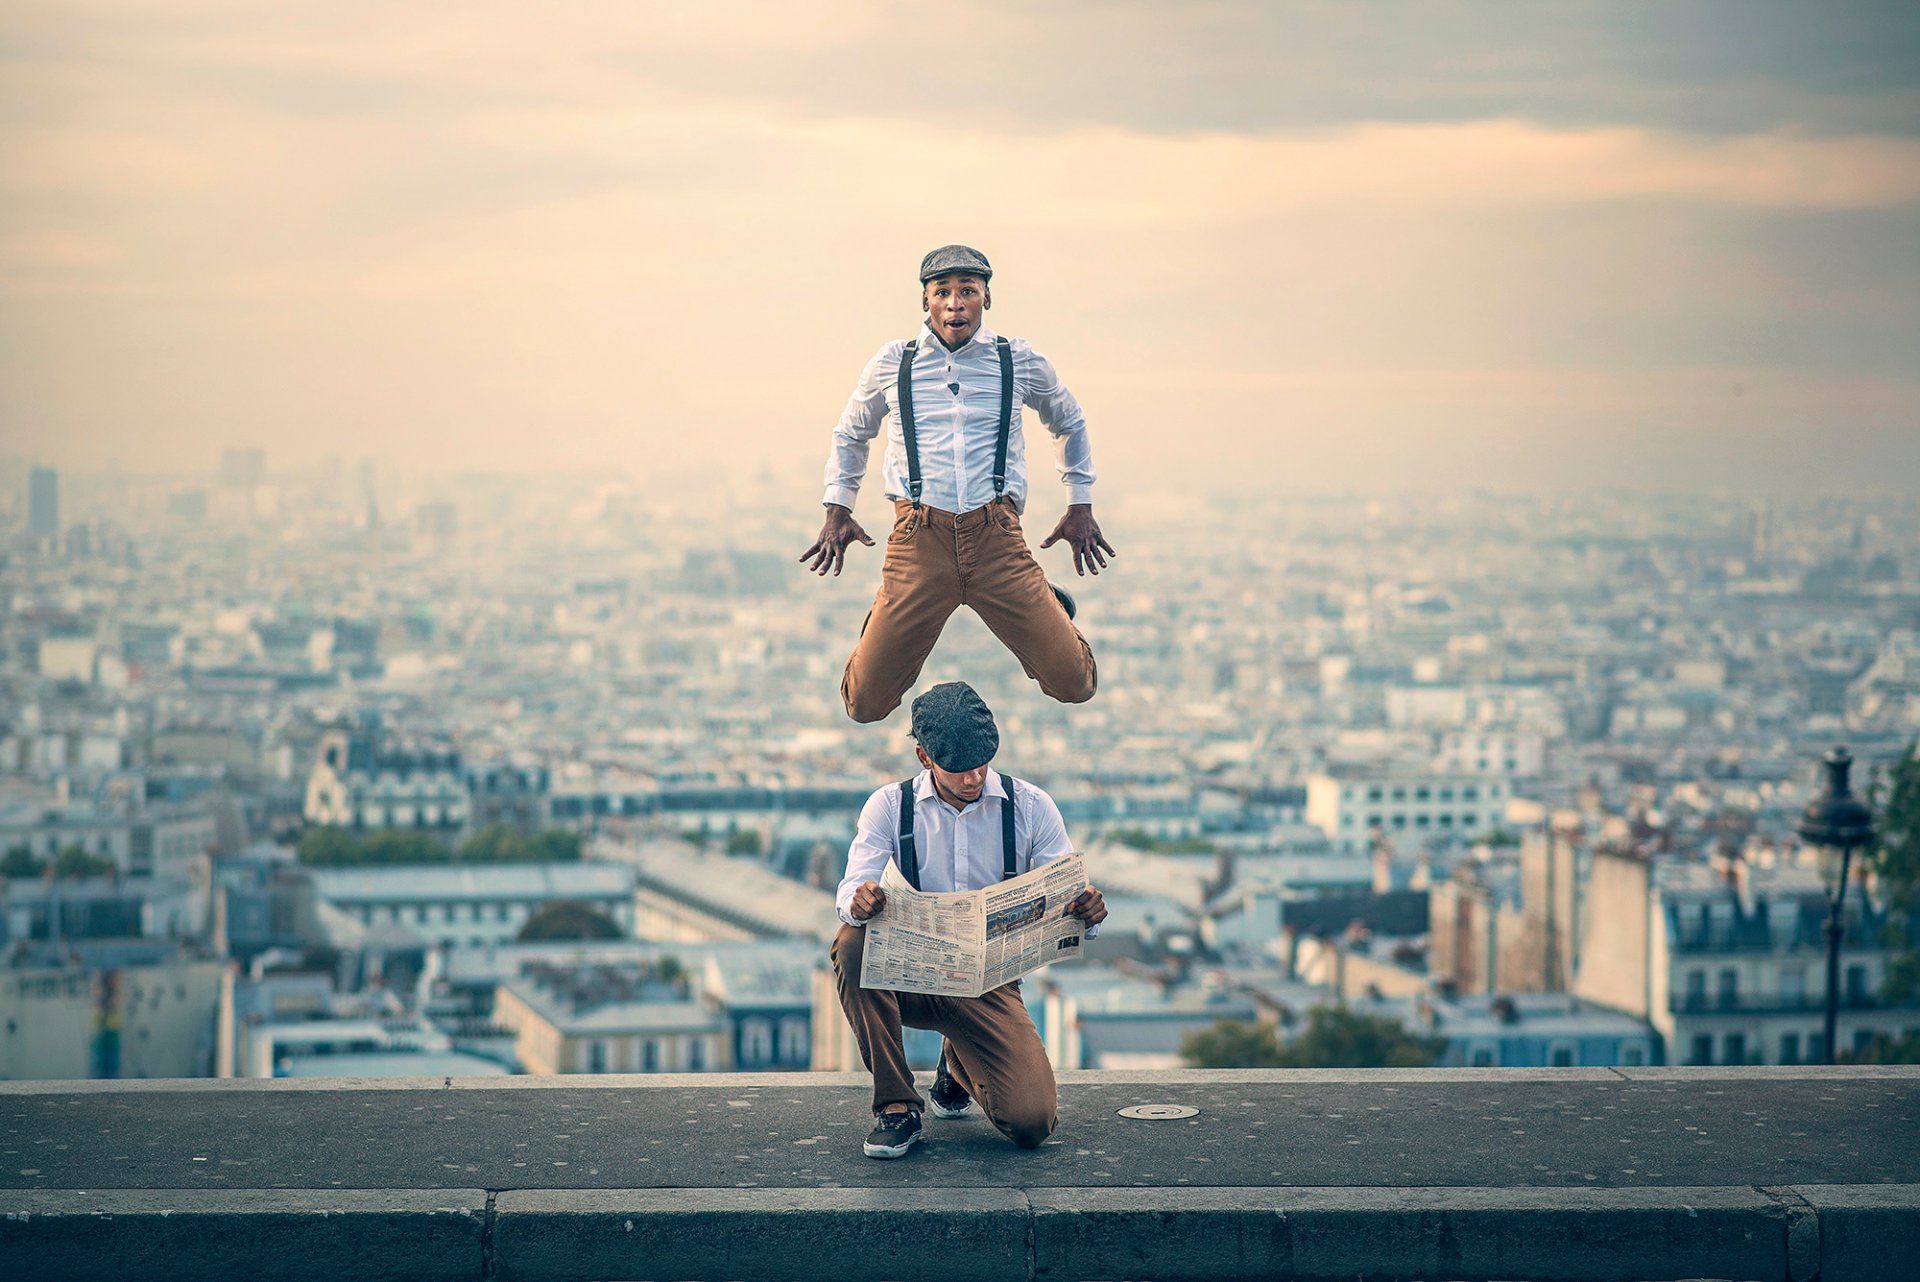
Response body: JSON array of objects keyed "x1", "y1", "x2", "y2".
[{"x1": 0, "y1": 1188, "x2": 486, "y2": 1282}]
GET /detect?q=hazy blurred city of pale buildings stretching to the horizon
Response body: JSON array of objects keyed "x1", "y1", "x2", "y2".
[{"x1": 0, "y1": 451, "x2": 1920, "y2": 1079}]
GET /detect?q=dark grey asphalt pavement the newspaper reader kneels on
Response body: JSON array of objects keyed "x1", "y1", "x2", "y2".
[{"x1": 0, "y1": 1069, "x2": 1920, "y2": 1190}]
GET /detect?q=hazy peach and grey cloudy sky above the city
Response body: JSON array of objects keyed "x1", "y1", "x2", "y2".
[{"x1": 0, "y1": 0, "x2": 1920, "y2": 493}]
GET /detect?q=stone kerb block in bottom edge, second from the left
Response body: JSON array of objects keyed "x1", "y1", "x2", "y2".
[{"x1": 493, "y1": 1188, "x2": 1029, "y2": 1282}]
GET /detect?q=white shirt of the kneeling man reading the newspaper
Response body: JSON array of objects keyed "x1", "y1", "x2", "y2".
[{"x1": 835, "y1": 770, "x2": 1092, "y2": 937}]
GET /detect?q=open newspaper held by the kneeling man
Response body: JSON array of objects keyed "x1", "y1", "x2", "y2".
[{"x1": 860, "y1": 850, "x2": 1087, "y2": 998}]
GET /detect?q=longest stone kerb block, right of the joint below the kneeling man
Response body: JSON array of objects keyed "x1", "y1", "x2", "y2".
[{"x1": 1031, "y1": 1188, "x2": 1788, "y2": 1282}]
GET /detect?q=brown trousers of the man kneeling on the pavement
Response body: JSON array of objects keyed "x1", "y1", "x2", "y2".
[{"x1": 831, "y1": 925, "x2": 1060, "y2": 1148}]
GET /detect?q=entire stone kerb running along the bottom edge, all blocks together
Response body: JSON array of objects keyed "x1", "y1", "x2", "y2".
[{"x1": 0, "y1": 1184, "x2": 1920, "y2": 1282}]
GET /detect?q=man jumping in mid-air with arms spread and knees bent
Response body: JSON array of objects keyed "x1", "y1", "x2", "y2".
[{"x1": 801, "y1": 246, "x2": 1114, "y2": 722}]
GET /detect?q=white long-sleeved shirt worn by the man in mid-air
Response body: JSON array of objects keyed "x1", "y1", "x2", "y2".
[{"x1": 822, "y1": 324, "x2": 1092, "y2": 512}]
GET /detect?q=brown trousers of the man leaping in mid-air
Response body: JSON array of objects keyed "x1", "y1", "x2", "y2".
[{"x1": 841, "y1": 499, "x2": 1096, "y2": 722}]
